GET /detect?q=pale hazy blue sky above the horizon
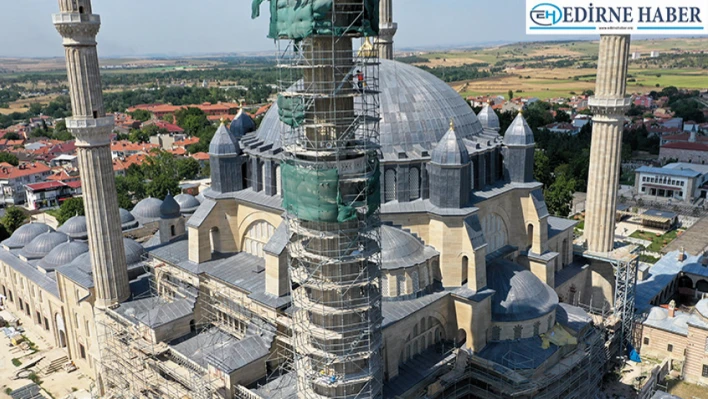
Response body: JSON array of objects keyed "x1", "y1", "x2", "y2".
[{"x1": 0, "y1": 0, "x2": 580, "y2": 57}]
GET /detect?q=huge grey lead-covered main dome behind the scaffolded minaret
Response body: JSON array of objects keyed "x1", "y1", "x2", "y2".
[{"x1": 256, "y1": 60, "x2": 482, "y2": 160}]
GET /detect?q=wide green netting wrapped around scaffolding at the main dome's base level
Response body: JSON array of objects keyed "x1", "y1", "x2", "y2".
[{"x1": 281, "y1": 161, "x2": 381, "y2": 223}]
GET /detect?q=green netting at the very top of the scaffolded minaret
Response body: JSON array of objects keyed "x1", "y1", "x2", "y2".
[{"x1": 251, "y1": 0, "x2": 379, "y2": 40}]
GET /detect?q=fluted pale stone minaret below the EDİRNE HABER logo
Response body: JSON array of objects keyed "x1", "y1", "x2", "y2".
[{"x1": 585, "y1": 35, "x2": 630, "y2": 253}]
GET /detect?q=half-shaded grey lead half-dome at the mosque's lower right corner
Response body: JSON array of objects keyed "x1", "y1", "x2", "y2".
[{"x1": 487, "y1": 261, "x2": 558, "y2": 322}]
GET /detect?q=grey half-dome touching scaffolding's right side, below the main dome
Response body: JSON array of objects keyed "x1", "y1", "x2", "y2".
[{"x1": 381, "y1": 225, "x2": 436, "y2": 269}]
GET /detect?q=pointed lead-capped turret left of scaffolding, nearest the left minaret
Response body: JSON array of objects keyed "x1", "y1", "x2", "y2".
[{"x1": 209, "y1": 118, "x2": 245, "y2": 194}]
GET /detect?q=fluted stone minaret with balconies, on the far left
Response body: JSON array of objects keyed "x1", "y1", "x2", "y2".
[{"x1": 53, "y1": 0, "x2": 130, "y2": 309}]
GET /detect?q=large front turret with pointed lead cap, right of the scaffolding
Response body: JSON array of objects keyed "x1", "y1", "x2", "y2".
[{"x1": 428, "y1": 122, "x2": 471, "y2": 208}]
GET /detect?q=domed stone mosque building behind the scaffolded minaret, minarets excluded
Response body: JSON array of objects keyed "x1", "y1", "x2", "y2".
[{"x1": 0, "y1": 0, "x2": 613, "y2": 399}]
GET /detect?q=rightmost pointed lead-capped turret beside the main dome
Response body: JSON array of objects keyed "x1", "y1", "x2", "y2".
[{"x1": 503, "y1": 112, "x2": 536, "y2": 183}]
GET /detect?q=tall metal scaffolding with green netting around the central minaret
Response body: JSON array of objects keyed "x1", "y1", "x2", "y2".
[{"x1": 271, "y1": 0, "x2": 383, "y2": 398}]
